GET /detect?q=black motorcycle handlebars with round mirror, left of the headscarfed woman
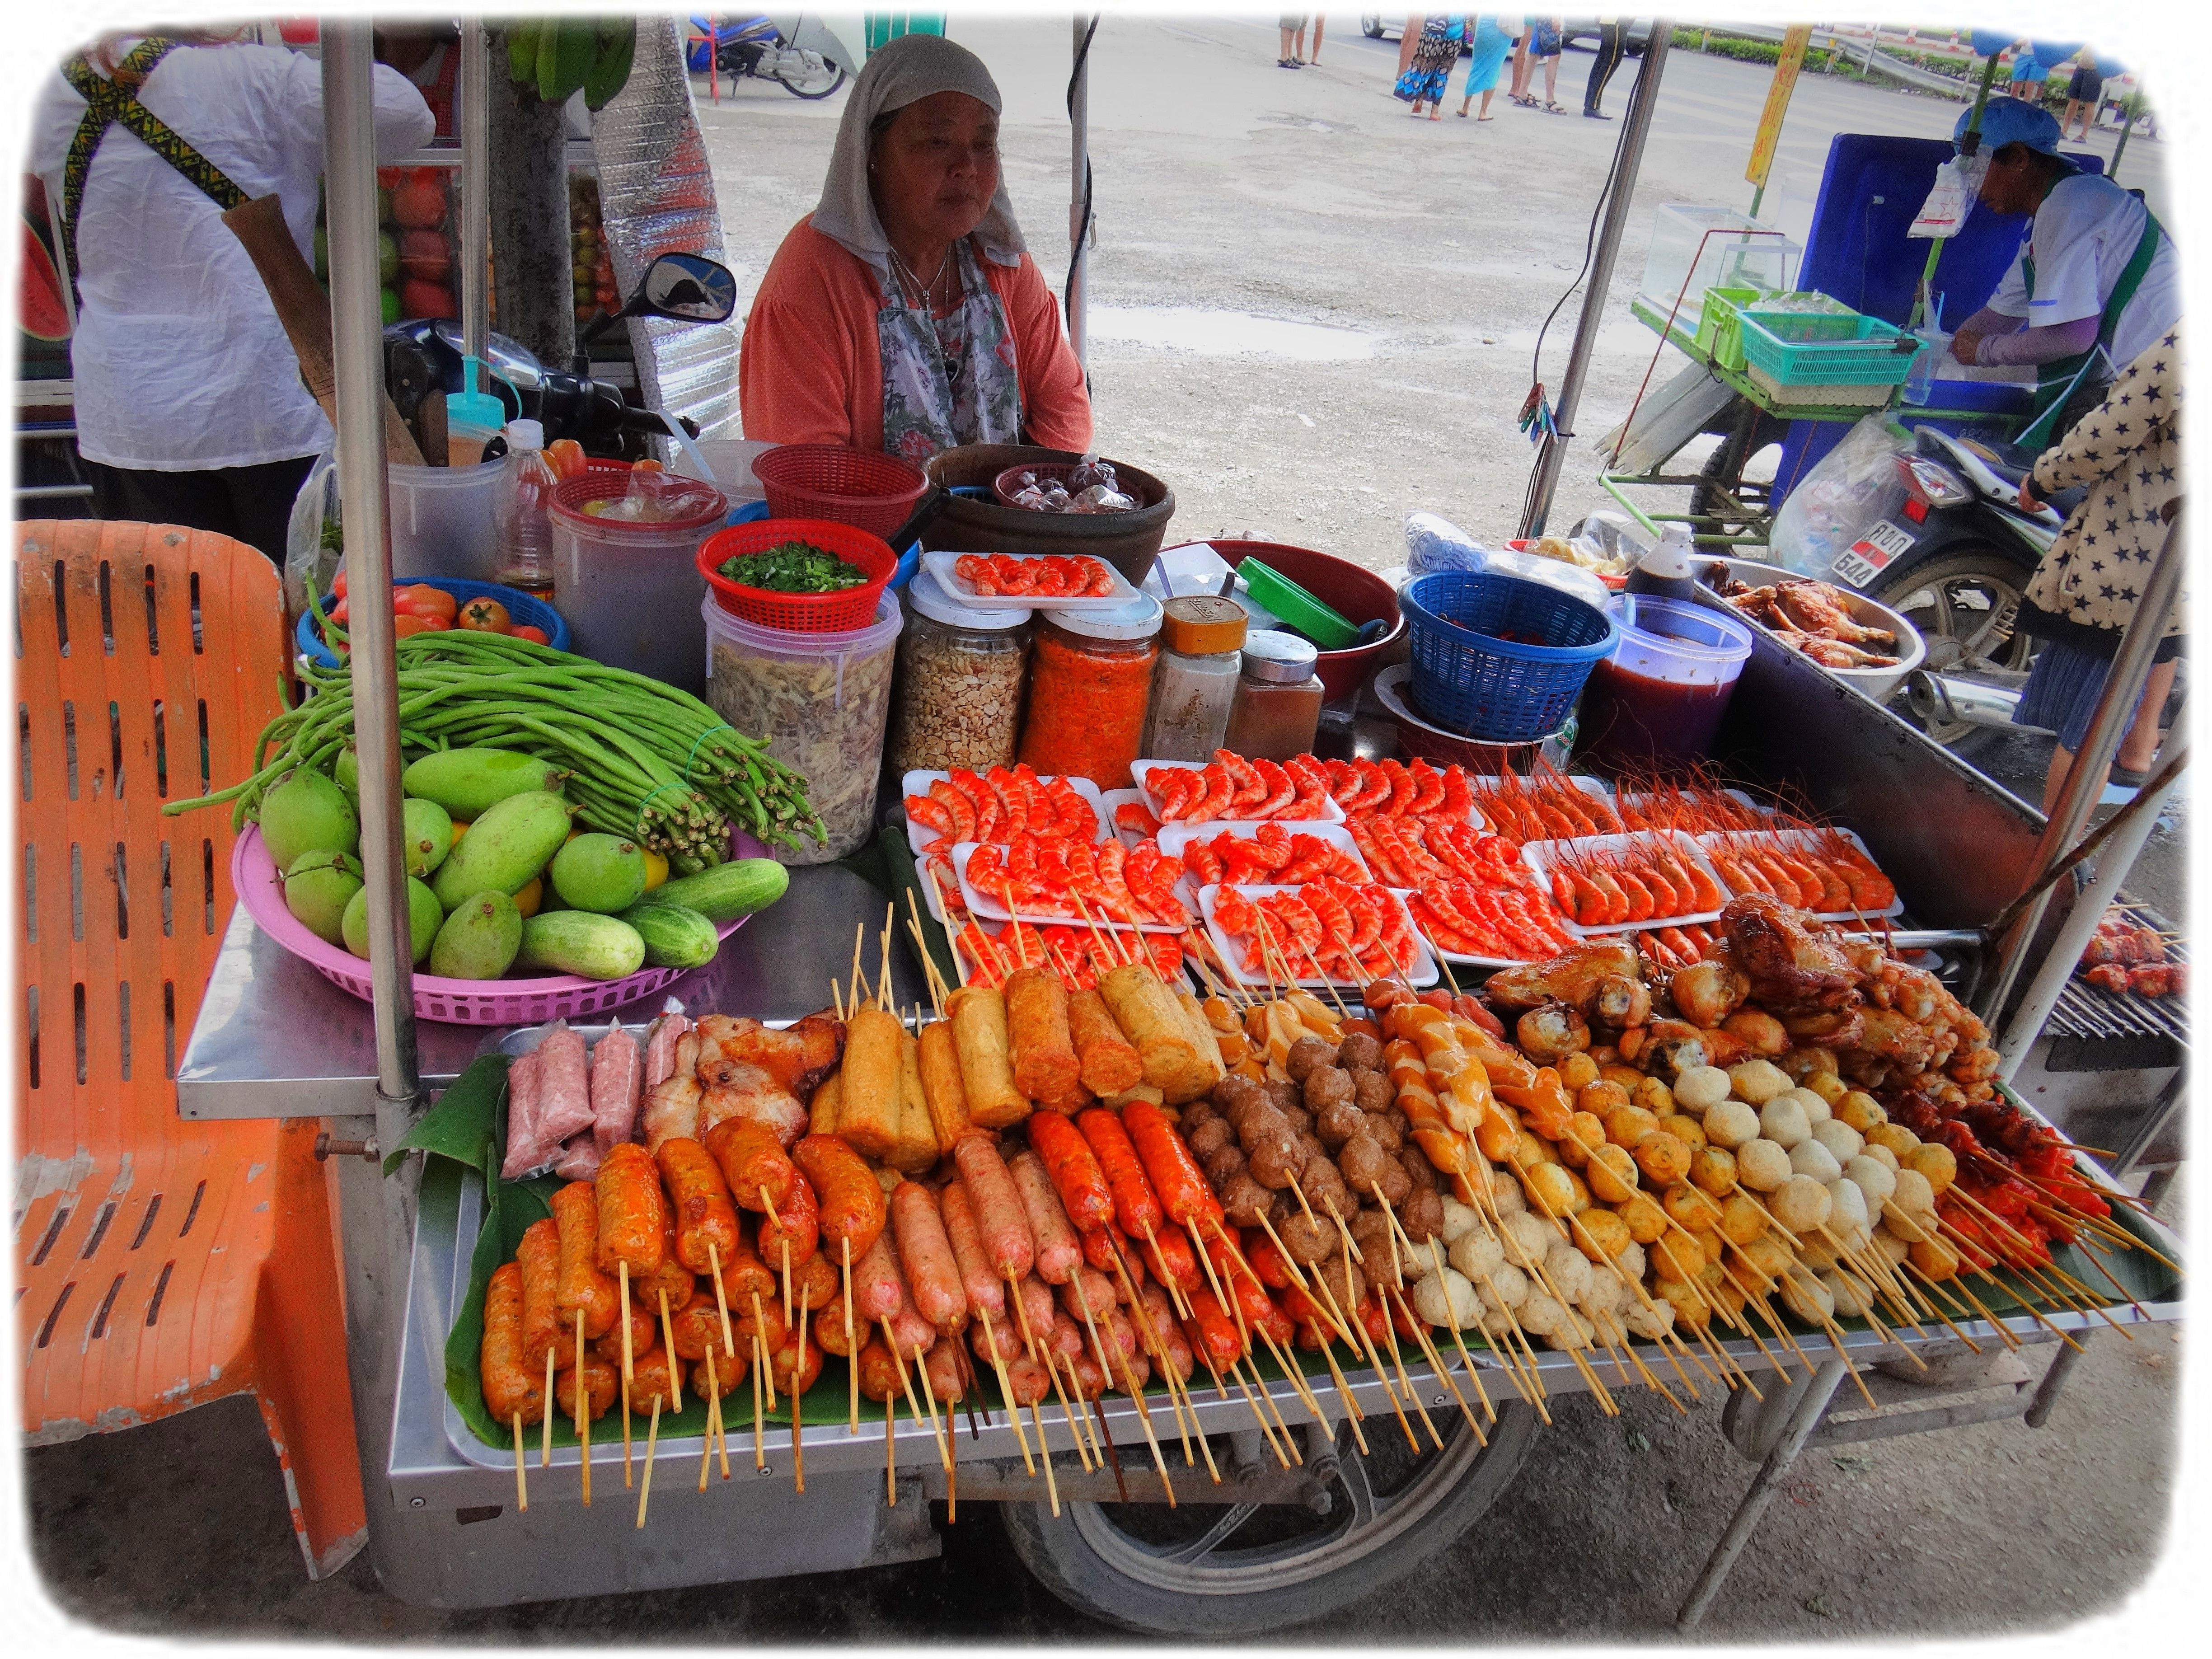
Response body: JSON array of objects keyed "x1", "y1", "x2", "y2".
[{"x1": 385, "y1": 254, "x2": 736, "y2": 458}]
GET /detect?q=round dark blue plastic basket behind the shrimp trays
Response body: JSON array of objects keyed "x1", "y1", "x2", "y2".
[{"x1": 1398, "y1": 571, "x2": 1619, "y2": 743}]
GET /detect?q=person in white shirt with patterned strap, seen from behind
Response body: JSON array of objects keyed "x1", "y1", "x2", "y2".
[{"x1": 31, "y1": 31, "x2": 434, "y2": 562}]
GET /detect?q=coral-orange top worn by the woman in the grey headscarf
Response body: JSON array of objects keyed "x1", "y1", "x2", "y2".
[{"x1": 736, "y1": 217, "x2": 1091, "y2": 451}]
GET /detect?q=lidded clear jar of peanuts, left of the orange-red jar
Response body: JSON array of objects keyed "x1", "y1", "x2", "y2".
[{"x1": 891, "y1": 571, "x2": 1029, "y2": 774}]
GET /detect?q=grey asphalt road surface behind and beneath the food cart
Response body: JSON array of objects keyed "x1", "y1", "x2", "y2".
[{"x1": 24, "y1": 18, "x2": 2181, "y2": 1641}]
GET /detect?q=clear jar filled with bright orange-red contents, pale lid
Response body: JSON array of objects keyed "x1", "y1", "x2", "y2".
[{"x1": 1022, "y1": 595, "x2": 1161, "y2": 790}]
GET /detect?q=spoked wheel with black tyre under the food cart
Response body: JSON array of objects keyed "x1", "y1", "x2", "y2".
[{"x1": 1000, "y1": 1400, "x2": 1537, "y2": 1637}]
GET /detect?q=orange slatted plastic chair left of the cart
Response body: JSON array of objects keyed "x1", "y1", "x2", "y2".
[{"x1": 13, "y1": 520, "x2": 367, "y2": 1577}]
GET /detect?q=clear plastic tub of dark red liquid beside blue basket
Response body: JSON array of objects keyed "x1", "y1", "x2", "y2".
[{"x1": 1575, "y1": 593, "x2": 1752, "y2": 776}]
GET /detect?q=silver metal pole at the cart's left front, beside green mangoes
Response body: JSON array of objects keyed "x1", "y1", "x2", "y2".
[{"x1": 323, "y1": 18, "x2": 420, "y2": 1146}]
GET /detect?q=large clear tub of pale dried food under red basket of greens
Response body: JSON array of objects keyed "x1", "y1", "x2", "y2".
[{"x1": 699, "y1": 593, "x2": 903, "y2": 865}]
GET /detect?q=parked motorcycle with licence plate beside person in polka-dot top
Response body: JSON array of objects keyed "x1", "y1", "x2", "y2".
[{"x1": 1829, "y1": 427, "x2": 2081, "y2": 756}]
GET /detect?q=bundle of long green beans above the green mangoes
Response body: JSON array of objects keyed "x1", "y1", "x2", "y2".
[{"x1": 161, "y1": 595, "x2": 823, "y2": 874}]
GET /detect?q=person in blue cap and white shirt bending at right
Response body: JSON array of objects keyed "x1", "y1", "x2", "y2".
[{"x1": 1951, "y1": 97, "x2": 2181, "y2": 449}]
